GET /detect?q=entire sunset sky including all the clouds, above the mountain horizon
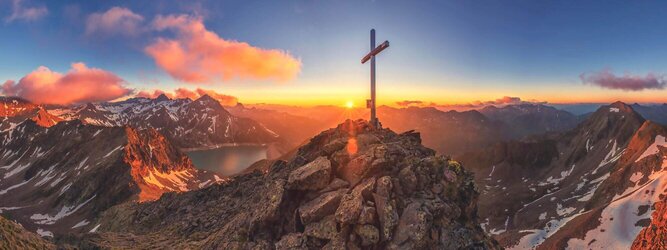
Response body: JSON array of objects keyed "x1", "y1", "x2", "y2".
[{"x1": 0, "y1": 0, "x2": 667, "y2": 106}]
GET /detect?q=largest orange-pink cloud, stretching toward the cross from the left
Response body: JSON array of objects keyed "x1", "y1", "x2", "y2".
[{"x1": 145, "y1": 15, "x2": 301, "y2": 83}]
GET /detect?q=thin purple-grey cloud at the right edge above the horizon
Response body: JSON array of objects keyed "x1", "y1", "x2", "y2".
[{"x1": 579, "y1": 69, "x2": 665, "y2": 91}]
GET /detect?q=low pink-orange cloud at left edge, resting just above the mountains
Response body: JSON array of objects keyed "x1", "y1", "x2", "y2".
[{"x1": 2, "y1": 63, "x2": 132, "y2": 104}]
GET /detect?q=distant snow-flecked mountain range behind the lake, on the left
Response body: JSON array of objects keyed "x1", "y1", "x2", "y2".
[{"x1": 47, "y1": 95, "x2": 279, "y2": 148}]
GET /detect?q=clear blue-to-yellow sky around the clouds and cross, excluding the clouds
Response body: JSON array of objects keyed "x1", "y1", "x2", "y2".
[{"x1": 0, "y1": 0, "x2": 667, "y2": 104}]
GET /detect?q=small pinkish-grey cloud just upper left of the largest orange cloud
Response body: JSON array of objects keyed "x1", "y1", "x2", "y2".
[{"x1": 86, "y1": 7, "x2": 144, "y2": 36}]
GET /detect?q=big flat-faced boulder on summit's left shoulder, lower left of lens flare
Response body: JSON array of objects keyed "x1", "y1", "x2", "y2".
[{"x1": 287, "y1": 156, "x2": 331, "y2": 190}]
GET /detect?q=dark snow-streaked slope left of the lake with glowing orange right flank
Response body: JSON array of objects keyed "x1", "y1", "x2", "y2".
[{"x1": 0, "y1": 121, "x2": 217, "y2": 235}]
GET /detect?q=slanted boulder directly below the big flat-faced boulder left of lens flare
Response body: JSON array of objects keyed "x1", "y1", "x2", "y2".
[{"x1": 299, "y1": 189, "x2": 347, "y2": 224}]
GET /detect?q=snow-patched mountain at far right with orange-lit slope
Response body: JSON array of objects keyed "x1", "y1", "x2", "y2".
[{"x1": 461, "y1": 102, "x2": 667, "y2": 249}]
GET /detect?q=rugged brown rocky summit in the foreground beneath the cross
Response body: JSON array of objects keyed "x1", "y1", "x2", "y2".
[{"x1": 77, "y1": 120, "x2": 499, "y2": 249}]
